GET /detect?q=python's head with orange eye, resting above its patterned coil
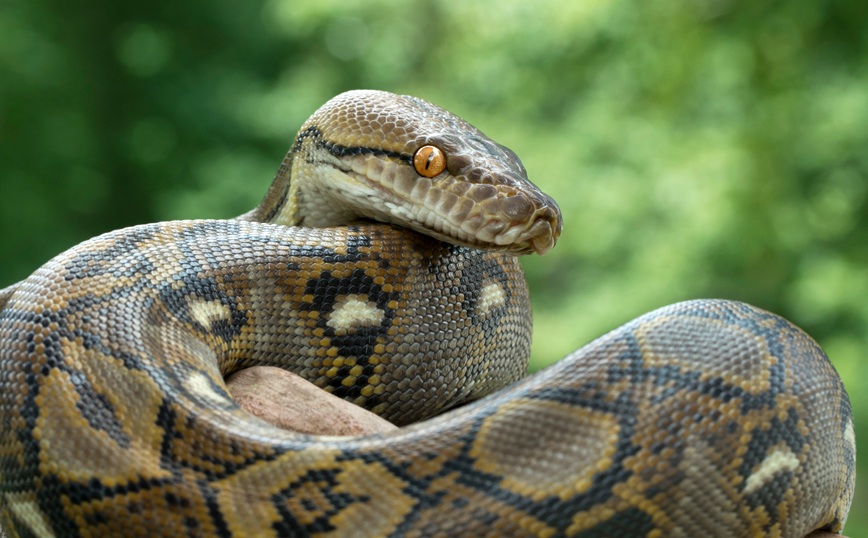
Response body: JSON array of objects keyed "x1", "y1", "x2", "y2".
[{"x1": 264, "y1": 90, "x2": 563, "y2": 254}]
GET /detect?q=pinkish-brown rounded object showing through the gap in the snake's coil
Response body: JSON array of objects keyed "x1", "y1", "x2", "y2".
[{"x1": 226, "y1": 366, "x2": 397, "y2": 435}]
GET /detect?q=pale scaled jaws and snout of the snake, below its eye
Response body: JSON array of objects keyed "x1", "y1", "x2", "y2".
[{"x1": 332, "y1": 156, "x2": 563, "y2": 255}]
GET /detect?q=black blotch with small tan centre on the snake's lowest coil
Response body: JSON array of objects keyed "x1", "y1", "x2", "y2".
[{"x1": 271, "y1": 469, "x2": 371, "y2": 536}]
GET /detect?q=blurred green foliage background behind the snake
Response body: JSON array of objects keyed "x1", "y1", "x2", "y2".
[{"x1": 0, "y1": 0, "x2": 868, "y2": 536}]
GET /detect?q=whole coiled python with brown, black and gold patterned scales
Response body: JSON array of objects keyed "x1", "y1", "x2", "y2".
[{"x1": 0, "y1": 91, "x2": 855, "y2": 538}]
